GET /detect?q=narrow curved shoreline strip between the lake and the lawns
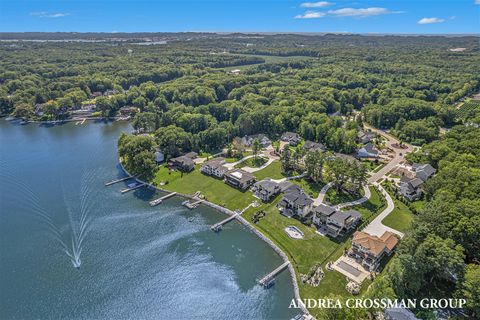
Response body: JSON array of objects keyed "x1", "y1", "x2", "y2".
[{"x1": 118, "y1": 161, "x2": 310, "y2": 315}]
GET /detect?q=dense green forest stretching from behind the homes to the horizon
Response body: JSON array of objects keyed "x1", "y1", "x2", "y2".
[{"x1": 0, "y1": 33, "x2": 480, "y2": 317}]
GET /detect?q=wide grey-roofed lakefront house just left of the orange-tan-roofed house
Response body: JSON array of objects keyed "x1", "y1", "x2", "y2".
[{"x1": 312, "y1": 204, "x2": 362, "y2": 238}]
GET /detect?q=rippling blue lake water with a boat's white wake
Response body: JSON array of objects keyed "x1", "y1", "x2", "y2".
[{"x1": 0, "y1": 120, "x2": 298, "y2": 319}]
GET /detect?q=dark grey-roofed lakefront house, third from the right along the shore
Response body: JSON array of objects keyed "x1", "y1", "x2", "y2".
[{"x1": 277, "y1": 185, "x2": 313, "y2": 218}]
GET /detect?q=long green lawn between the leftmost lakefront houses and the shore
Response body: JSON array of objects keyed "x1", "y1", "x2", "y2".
[{"x1": 154, "y1": 166, "x2": 255, "y2": 210}]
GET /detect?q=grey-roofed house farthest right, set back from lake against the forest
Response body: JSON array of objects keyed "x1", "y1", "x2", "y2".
[{"x1": 399, "y1": 163, "x2": 436, "y2": 201}]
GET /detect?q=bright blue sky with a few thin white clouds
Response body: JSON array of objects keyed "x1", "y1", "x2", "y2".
[{"x1": 0, "y1": 0, "x2": 480, "y2": 34}]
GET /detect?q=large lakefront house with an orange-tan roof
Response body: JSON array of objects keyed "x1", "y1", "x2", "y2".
[{"x1": 348, "y1": 231, "x2": 398, "y2": 271}]
